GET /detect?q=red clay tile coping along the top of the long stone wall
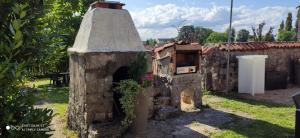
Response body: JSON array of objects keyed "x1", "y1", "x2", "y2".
[{"x1": 202, "y1": 42, "x2": 300, "y2": 54}]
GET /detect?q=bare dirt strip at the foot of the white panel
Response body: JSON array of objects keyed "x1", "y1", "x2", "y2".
[{"x1": 239, "y1": 86, "x2": 300, "y2": 105}]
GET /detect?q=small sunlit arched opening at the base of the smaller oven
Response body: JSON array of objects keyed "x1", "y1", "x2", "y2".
[{"x1": 180, "y1": 89, "x2": 196, "y2": 112}]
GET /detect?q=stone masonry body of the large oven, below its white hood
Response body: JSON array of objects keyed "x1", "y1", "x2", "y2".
[{"x1": 68, "y1": 52, "x2": 145, "y2": 137}]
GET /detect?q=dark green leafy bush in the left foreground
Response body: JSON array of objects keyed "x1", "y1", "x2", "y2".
[{"x1": 0, "y1": 0, "x2": 53, "y2": 137}]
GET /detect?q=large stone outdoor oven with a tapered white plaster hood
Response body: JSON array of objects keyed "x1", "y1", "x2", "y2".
[{"x1": 68, "y1": 1, "x2": 146, "y2": 137}]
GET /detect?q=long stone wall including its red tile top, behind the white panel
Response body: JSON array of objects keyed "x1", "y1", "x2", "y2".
[{"x1": 201, "y1": 42, "x2": 300, "y2": 92}]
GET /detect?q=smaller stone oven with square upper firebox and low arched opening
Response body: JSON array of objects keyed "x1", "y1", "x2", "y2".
[{"x1": 153, "y1": 41, "x2": 202, "y2": 118}]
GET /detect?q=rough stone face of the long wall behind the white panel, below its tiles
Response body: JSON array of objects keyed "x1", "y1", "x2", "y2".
[{"x1": 201, "y1": 48, "x2": 300, "y2": 91}]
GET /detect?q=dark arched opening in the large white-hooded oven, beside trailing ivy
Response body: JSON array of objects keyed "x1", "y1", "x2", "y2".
[{"x1": 113, "y1": 67, "x2": 129, "y2": 119}]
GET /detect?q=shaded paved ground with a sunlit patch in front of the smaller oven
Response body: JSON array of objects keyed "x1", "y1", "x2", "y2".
[{"x1": 125, "y1": 108, "x2": 251, "y2": 138}]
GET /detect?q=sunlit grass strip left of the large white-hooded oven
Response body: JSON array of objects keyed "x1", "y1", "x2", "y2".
[{"x1": 25, "y1": 79, "x2": 77, "y2": 138}]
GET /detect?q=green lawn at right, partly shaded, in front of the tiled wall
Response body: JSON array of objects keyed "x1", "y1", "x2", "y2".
[{"x1": 203, "y1": 91, "x2": 295, "y2": 138}]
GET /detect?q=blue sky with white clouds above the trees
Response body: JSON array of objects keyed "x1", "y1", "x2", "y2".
[{"x1": 121, "y1": 0, "x2": 300, "y2": 40}]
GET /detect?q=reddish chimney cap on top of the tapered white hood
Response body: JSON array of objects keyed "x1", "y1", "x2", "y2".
[{"x1": 90, "y1": 0, "x2": 125, "y2": 9}]
